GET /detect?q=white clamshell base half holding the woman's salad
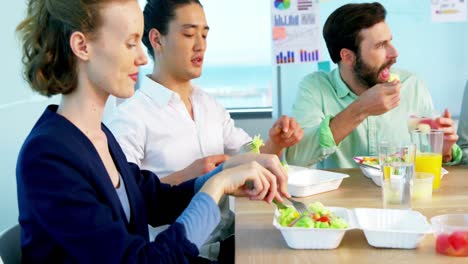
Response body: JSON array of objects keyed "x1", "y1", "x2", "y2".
[{"x1": 273, "y1": 207, "x2": 354, "y2": 249}]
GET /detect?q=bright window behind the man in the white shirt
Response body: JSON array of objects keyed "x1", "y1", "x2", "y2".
[{"x1": 139, "y1": 0, "x2": 273, "y2": 112}]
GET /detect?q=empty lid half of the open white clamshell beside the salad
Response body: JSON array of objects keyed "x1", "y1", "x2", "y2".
[{"x1": 353, "y1": 208, "x2": 432, "y2": 249}]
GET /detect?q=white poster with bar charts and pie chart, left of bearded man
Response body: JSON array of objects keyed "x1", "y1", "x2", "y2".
[{"x1": 271, "y1": 0, "x2": 322, "y2": 65}]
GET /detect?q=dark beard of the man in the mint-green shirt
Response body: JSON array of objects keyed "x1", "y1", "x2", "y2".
[{"x1": 353, "y1": 53, "x2": 396, "y2": 88}]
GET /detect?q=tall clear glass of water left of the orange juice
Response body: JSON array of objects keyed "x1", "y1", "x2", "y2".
[{"x1": 379, "y1": 142, "x2": 416, "y2": 209}]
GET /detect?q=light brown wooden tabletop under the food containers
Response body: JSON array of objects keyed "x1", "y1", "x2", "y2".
[{"x1": 235, "y1": 166, "x2": 468, "y2": 264}]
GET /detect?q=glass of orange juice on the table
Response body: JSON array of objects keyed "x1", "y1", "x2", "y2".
[{"x1": 411, "y1": 129, "x2": 444, "y2": 190}]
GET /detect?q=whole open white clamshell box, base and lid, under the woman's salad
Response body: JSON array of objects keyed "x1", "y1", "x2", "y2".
[{"x1": 273, "y1": 207, "x2": 432, "y2": 249}]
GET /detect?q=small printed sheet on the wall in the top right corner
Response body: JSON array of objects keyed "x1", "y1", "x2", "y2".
[{"x1": 431, "y1": 0, "x2": 468, "y2": 22}]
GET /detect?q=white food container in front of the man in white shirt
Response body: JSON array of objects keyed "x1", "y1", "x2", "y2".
[{"x1": 288, "y1": 165, "x2": 349, "y2": 197}]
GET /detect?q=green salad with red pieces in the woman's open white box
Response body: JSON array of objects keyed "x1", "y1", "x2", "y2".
[{"x1": 277, "y1": 202, "x2": 349, "y2": 229}]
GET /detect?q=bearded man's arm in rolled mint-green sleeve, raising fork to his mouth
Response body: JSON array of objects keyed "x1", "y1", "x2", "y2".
[{"x1": 286, "y1": 74, "x2": 400, "y2": 166}]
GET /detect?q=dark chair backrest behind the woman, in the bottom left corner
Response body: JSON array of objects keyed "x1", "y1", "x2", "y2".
[{"x1": 0, "y1": 224, "x2": 21, "y2": 264}]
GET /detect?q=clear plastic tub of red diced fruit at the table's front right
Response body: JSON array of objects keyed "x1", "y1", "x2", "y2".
[{"x1": 431, "y1": 214, "x2": 468, "y2": 257}]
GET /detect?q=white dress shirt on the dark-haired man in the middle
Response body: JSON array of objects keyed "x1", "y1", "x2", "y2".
[{"x1": 105, "y1": 76, "x2": 251, "y2": 178}]
